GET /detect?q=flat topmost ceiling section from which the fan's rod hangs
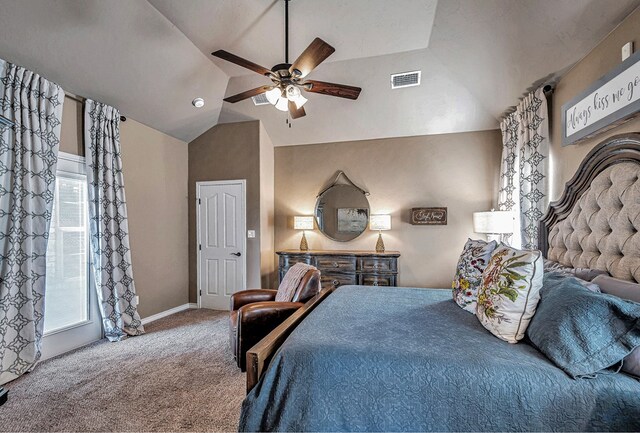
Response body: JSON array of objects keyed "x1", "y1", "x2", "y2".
[{"x1": 149, "y1": 0, "x2": 437, "y2": 76}]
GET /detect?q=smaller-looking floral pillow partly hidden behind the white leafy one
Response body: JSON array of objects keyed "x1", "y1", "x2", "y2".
[{"x1": 451, "y1": 239, "x2": 498, "y2": 314}]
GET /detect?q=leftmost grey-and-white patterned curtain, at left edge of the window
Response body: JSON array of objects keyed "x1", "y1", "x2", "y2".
[{"x1": 0, "y1": 60, "x2": 64, "y2": 385}]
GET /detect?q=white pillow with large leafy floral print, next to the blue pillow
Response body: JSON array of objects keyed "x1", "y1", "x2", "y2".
[{"x1": 476, "y1": 244, "x2": 544, "y2": 343}]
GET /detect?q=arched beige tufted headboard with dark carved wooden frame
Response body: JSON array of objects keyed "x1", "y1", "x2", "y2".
[{"x1": 539, "y1": 134, "x2": 640, "y2": 282}]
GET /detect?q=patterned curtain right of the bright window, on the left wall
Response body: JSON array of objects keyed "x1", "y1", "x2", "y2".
[{"x1": 84, "y1": 100, "x2": 144, "y2": 341}]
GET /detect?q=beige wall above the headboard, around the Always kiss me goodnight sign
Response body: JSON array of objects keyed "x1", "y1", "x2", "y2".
[{"x1": 550, "y1": 9, "x2": 640, "y2": 200}]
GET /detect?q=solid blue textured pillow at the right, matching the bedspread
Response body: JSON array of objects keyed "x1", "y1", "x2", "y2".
[{"x1": 527, "y1": 273, "x2": 640, "y2": 379}]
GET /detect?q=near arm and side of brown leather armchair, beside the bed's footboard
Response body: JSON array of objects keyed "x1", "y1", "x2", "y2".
[{"x1": 238, "y1": 302, "x2": 304, "y2": 364}]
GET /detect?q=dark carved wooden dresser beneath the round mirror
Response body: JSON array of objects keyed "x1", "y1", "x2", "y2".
[{"x1": 276, "y1": 250, "x2": 400, "y2": 289}]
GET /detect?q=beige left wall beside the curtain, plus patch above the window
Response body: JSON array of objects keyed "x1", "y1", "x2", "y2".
[{"x1": 60, "y1": 98, "x2": 188, "y2": 318}]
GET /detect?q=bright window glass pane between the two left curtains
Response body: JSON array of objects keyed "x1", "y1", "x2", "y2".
[{"x1": 44, "y1": 172, "x2": 89, "y2": 332}]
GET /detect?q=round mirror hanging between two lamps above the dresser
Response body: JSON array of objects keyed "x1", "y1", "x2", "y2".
[{"x1": 315, "y1": 184, "x2": 369, "y2": 242}]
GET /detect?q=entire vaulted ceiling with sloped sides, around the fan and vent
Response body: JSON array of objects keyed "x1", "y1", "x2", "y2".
[{"x1": 0, "y1": 0, "x2": 640, "y2": 145}]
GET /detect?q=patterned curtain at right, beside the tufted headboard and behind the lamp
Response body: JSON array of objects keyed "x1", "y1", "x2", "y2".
[{"x1": 498, "y1": 87, "x2": 549, "y2": 250}]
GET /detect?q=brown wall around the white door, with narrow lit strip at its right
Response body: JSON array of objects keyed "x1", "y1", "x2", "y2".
[{"x1": 189, "y1": 120, "x2": 273, "y2": 302}]
